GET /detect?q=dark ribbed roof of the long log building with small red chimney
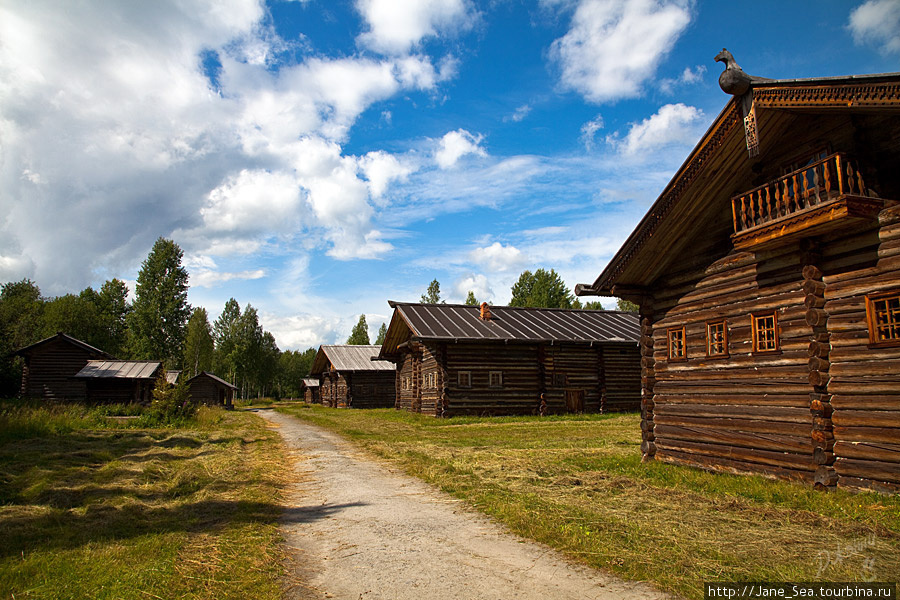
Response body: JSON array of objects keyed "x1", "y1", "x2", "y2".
[{"x1": 380, "y1": 302, "x2": 640, "y2": 356}]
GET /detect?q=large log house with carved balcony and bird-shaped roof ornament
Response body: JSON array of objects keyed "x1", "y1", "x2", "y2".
[{"x1": 576, "y1": 59, "x2": 900, "y2": 491}]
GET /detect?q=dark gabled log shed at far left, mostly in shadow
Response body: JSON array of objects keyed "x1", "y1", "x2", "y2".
[{"x1": 16, "y1": 333, "x2": 112, "y2": 400}]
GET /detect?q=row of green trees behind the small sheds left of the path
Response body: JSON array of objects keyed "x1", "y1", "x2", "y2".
[{"x1": 0, "y1": 238, "x2": 316, "y2": 398}]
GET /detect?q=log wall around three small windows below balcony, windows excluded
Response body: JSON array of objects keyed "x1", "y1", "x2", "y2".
[{"x1": 643, "y1": 241, "x2": 815, "y2": 481}]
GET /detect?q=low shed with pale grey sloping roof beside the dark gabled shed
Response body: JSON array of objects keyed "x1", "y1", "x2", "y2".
[{"x1": 75, "y1": 360, "x2": 166, "y2": 404}]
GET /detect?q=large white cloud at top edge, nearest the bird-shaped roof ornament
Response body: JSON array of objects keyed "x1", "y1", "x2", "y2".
[{"x1": 551, "y1": 0, "x2": 691, "y2": 102}]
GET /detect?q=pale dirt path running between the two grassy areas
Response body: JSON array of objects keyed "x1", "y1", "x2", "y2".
[{"x1": 258, "y1": 410, "x2": 667, "y2": 600}]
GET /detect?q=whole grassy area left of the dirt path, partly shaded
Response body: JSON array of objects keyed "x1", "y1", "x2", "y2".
[{"x1": 0, "y1": 402, "x2": 287, "y2": 600}]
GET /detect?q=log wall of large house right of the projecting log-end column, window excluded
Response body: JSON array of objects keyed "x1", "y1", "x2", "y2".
[{"x1": 821, "y1": 207, "x2": 900, "y2": 492}]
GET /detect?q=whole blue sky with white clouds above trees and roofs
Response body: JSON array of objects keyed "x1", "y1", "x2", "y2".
[{"x1": 0, "y1": 0, "x2": 900, "y2": 349}]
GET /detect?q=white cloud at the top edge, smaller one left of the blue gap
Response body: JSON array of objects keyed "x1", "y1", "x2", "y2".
[{"x1": 356, "y1": 0, "x2": 475, "y2": 54}]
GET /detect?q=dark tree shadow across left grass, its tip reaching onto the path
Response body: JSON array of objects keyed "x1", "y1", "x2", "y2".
[{"x1": 0, "y1": 431, "x2": 366, "y2": 558}]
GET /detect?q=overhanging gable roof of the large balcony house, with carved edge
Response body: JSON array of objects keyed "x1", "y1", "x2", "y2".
[{"x1": 575, "y1": 73, "x2": 900, "y2": 298}]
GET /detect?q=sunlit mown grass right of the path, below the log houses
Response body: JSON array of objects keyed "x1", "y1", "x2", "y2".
[{"x1": 279, "y1": 405, "x2": 900, "y2": 598}]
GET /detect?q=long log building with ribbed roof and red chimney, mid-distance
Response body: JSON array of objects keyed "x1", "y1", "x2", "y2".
[{"x1": 379, "y1": 302, "x2": 641, "y2": 416}]
